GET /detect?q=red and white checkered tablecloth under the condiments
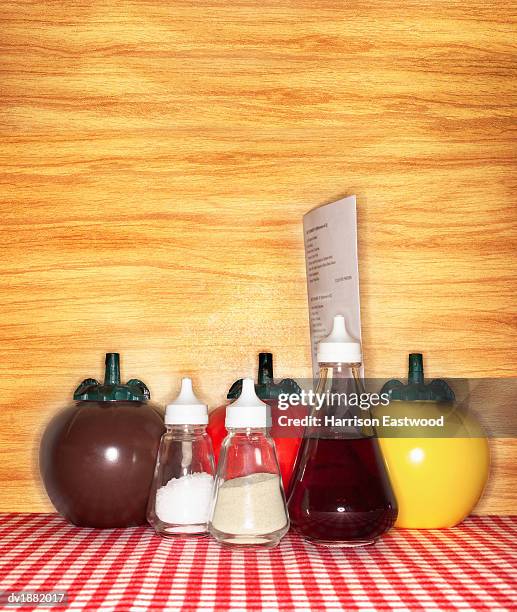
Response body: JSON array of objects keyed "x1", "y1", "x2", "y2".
[{"x1": 0, "y1": 514, "x2": 517, "y2": 611}]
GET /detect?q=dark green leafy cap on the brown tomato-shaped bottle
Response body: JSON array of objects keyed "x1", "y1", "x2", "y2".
[{"x1": 74, "y1": 353, "x2": 151, "y2": 402}]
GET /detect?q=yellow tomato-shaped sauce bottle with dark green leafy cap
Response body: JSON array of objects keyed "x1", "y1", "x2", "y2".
[{"x1": 374, "y1": 353, "x2": 490, "y2": 529}]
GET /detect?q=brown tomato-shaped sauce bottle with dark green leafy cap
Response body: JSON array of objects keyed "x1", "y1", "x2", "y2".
[{"x1": 39, "y1": 353, "x2": 164, "y2": 528}]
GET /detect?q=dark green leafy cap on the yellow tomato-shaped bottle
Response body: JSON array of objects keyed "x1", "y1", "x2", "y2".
[{"x1": 381, "y1": 353, "x2": 455, "y2": 402}]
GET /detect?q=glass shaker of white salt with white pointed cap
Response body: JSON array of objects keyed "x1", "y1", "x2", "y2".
[{"x1": 147, "y1": 378, "x2": 215, "y2": 536}]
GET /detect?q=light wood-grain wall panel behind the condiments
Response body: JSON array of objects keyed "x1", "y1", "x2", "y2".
[{"x1": 0, "y1": 0, "x2": 517, "y2": 513}]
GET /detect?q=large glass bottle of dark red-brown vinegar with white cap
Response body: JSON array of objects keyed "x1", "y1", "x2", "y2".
[{"x1": 288, "y1": 315, "x2": 397, "y2": 547}]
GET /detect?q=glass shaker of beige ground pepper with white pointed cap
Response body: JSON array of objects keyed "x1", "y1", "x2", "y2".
[{"x1": 209, "y1": 378, "x2": 289, "y2": 547}]
